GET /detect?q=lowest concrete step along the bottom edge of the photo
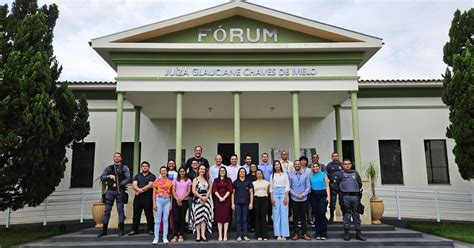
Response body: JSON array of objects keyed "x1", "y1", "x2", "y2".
[{"x1": 21, "y1": 237, "x2": 453, "y2": 248}]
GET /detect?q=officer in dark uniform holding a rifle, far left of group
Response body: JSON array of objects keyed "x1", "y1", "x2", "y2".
[{"x1": 97, "y1": 152, "x2": 130, "y2": 237}]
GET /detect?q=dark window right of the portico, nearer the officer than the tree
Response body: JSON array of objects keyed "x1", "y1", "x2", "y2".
[{"x1": 379, "y1": 140, "x2": 403, "y2": 184}]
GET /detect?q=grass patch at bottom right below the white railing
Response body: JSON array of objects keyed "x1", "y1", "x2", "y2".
[{"x1": 407, "y1": 222, "x2": 474, "y2": 244}]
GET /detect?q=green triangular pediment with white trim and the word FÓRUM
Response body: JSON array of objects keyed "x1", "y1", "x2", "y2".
[{"x1": 91, "y1": 1, "x2": 383, "y2": 68}]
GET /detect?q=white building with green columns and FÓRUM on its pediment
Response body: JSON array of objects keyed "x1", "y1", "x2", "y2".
[{"x1": 2, "y1": 1, "x2": 474, "y2": 226}]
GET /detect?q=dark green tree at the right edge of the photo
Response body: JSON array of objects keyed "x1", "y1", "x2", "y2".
[{"x1": 442, "y1": 9, "x2": 474, "y2": 180}]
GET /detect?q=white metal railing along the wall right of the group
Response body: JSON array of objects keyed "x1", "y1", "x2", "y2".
[{"x1": 376, "y1": 186, "x2": 474, "y2": 222}]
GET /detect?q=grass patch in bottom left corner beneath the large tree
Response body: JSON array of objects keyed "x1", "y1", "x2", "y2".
[{"x1": 0, "y1": 226, "x2": 64, "y2": 248}]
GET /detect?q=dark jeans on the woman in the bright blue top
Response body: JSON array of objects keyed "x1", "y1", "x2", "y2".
[{"x1": 311, "y1": 189, "x2": 328, "y2": 237}]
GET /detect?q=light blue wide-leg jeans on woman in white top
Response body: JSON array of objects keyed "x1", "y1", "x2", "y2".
[{"x1": 272, "y1": 187, "x2": 290, "y2": 237}]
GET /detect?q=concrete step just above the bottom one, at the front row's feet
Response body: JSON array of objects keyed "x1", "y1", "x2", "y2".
[{"x1": 51, "y1": 229, "x2": 423, "y2": 242}]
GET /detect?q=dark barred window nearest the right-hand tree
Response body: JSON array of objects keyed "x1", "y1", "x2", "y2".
[{"x1": 425, "y1": 140, "x2": 449, "y2": 184}]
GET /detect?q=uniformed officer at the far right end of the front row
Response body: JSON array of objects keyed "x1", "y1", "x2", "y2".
[{"x1": 336, "y1": 159, "x2": 366, "y2": 241}]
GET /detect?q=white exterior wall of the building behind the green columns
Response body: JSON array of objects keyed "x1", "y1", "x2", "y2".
[{"x1": 58, "y1": 98, "x2": 472, "y2": 190}]
